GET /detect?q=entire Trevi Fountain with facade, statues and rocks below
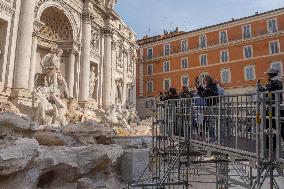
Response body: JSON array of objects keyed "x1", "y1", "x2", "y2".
[{"x1": 0, "y1": 0, "x2": 151, "y2": 189}]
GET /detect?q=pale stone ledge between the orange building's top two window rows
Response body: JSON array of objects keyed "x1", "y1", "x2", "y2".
[{"x1": 140, "y1": 31, "x2": 284, "y2": 63}]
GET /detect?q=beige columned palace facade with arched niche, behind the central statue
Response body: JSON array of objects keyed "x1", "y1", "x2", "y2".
[{"x1": 0, "y1": 0, "x2": 137, "y2": 108}]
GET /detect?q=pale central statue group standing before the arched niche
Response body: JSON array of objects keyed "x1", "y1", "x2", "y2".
[{"x1": 33, "y1": 48, "x2": 69, "y2": 126}]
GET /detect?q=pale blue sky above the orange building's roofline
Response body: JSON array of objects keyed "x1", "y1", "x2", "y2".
[{"x1": 115, "y1": 0, "x2": 284, "y2": 39}]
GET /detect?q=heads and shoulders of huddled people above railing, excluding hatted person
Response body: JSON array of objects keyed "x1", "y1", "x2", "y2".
[{"x1": 160, "y1": 75, "x2": 225, "y2": 101}]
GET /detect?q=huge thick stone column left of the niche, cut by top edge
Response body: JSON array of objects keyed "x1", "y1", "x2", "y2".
[{"x1": 13, "y1": 0, "x2": 35, "y2": 91}]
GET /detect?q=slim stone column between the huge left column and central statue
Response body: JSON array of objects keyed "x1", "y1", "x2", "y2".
[{"x1": 29, "y1": 34, "x2": 38, "y2": 92}]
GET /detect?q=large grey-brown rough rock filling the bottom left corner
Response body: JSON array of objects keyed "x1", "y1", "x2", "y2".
[{"x1": 0, "y1": 142, "x2": 123, "y2": 189}]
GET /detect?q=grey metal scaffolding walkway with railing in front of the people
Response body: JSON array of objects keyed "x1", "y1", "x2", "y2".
[{"x1": 129, "y1": 91, "x2": 284, "y2": 189}]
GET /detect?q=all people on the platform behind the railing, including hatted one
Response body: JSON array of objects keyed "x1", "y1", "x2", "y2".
[{"x1": 160, "y1": 68, "x2": 284, "y2": 145}]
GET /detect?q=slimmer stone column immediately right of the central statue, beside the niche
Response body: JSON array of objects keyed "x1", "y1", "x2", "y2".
[{"x1": 68, "y1": 49, "x2": 77, "y2": 98}]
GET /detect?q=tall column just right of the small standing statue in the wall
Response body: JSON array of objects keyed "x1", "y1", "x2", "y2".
[{"x1": 102, "y1": 28, "x2": 113, "y2": 108}]
